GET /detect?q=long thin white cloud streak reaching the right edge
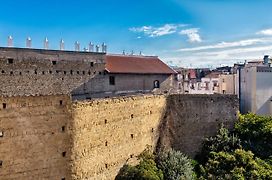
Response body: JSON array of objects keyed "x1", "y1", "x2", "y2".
[{"x1": 178, "y1": 38, "x2": 272, "y2": 52}]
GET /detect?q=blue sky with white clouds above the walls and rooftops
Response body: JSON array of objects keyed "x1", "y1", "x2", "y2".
[{"x1": 0, "y1": 0, "x2": 272, "y2": 67}]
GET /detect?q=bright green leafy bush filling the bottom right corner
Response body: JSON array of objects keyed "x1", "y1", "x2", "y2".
[{"x1": 200, "y1": 149, "x2": 272, "y2": 179}]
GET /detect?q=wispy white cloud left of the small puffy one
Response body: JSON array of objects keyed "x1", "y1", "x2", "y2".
[{"x1": 129, "y1": 24, "x2": 187, "y2": 37}]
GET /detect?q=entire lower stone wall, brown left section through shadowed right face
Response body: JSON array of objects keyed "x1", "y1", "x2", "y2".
[{"x1": 0, "y1": 95, "x2": 238, "y2": 180}]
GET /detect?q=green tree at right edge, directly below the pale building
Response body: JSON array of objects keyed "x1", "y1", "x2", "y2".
[{"x1": 235, "y1": 114, "x2": 272, "y2": 159}]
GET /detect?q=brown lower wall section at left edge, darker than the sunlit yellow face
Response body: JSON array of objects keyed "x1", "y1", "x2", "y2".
[{"x1": 0, "y1": 95, "x2": 71, "y2": 180}]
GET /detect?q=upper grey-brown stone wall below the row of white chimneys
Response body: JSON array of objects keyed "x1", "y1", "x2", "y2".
[{"x1": 0, "y1": 48, "x2": 105, "y2": 96}]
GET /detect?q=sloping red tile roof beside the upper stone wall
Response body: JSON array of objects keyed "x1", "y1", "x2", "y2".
[{"x1": 106, "y1": 55, "x2": 176, "y2": 74}]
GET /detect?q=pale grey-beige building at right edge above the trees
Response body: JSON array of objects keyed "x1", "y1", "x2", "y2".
[{"x1": 240, "y1": 66, "x2": 272, "y2": 115}]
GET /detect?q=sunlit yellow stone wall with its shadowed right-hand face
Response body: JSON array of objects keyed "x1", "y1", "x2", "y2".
[{"x1": 71, "y1": 95, "x2": 238, "y2": 179}]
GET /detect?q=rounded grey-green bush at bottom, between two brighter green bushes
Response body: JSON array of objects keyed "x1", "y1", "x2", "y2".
[{"x1": 156, "y1": 150, "x2": 194, "y2": 180}]
